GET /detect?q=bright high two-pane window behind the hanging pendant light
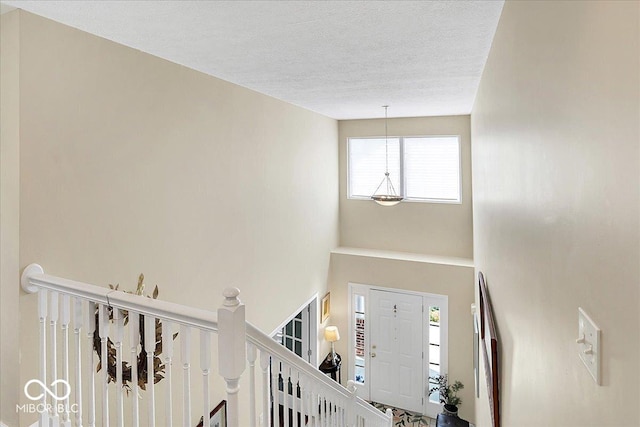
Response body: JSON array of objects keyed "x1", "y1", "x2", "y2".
[{"x1": 347, "y1": 136, "x2": 462, "y2": 203}]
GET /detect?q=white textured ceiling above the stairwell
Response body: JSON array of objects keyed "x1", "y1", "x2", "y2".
[{"x1": 2, "y1": 0, "x2": 503, "y2": 119}]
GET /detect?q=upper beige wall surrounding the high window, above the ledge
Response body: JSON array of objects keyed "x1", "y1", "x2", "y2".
[{"x1": 339, "y1": 116, "x2": 473, "y2": 258}]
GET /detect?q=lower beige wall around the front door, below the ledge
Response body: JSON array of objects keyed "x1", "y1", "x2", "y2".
[{"x1": 327, "y1": 254, "x2": 474, "y2": 421}]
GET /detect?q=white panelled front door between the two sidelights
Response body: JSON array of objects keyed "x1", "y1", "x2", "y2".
[{"x1": 369, "y1": 290, "x2": 424, "y2": 413}]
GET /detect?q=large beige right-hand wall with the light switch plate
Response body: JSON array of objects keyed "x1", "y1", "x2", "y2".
[{"x1": 471, "y1": 1, "x2": 640, "y2": 427}]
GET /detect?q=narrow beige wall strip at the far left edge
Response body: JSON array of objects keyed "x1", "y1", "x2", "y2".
[{"x1": 0, "y1": 11, "x2": 21, "y2": 425}]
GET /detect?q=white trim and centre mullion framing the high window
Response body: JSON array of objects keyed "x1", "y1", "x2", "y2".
[{"x1": 346, "y1": 134, "x2": 464, "y2": 205}]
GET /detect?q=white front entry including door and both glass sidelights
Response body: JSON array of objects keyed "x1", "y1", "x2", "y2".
[{"x1": 343, "y1": 283, "x2": 448, "y2": 417}]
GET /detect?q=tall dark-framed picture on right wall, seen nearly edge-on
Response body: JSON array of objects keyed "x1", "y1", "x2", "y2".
[{"x1": 478, "y1": 272, "x2": 500, "y2": 427}]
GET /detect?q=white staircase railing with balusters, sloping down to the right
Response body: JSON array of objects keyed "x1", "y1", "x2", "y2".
[{"x1": 21, "y1": 264, "x2": 392, "y2": 427}]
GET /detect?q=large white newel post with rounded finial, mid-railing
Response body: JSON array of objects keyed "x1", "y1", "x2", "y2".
[{"x1": 218, "y1": 288, "x2": 247, "y2": 427}]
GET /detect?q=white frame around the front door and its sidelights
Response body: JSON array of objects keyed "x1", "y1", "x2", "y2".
[{"x1": 347, "y1": 282, "x2": 449, "y2": 417}]
